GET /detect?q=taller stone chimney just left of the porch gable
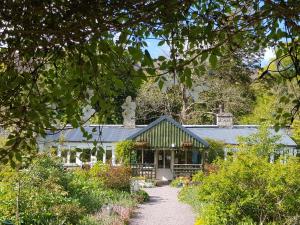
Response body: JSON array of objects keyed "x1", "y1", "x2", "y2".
[{"x1": 122, "y1": 96, "x2": 136, "y2": 128}]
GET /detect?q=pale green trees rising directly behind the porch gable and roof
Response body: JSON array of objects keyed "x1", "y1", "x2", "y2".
[{"x1": 136, "y1": 48, "x2": 261, "y2": 124}]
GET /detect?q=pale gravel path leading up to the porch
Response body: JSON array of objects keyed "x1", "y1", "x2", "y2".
[{"x1": 130, "y1": 186, "x2": 195, "y2": 225}]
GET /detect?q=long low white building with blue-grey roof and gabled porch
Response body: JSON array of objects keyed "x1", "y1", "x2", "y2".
[{"x1": 38, "y1": 113, "x2": 297, "y2": 180}]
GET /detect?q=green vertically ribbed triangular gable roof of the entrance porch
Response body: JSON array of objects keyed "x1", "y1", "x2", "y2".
[{"x1": 127, "y1": 116, "x2": 209, "y2": 148}]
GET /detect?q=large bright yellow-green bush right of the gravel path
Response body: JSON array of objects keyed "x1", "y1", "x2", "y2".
[{"x1": 179, "y1": 128, "x2": 300, "y2": 225}]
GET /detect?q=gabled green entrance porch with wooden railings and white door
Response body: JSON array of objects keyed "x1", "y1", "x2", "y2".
[{"x1": 128, "y1": 116, "x2": 208, "y2": 180}]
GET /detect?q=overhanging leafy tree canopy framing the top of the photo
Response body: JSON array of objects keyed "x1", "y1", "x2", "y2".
[{"x1": 0, "y1": 0, "x2": 300, "y2": 162}]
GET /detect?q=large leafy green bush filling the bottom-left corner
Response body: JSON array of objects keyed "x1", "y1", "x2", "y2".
[{"x1": 0, "y1": 155, "x2": 85, "y2": 224}]
